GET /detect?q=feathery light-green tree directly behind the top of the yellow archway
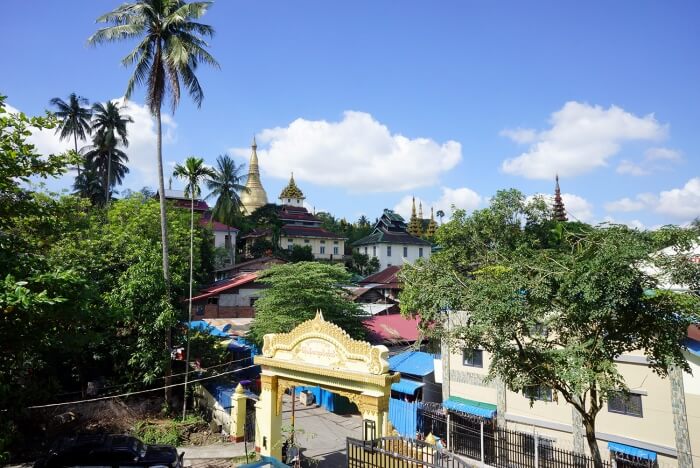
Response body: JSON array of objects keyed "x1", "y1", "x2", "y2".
[{"x1": 250, "y1": 262, "x2": 365, "y2": 344}]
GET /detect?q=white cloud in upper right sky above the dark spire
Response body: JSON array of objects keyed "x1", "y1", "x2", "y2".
[{"x1": 501, "y1": 101, "x2": 667, "y2": 179}]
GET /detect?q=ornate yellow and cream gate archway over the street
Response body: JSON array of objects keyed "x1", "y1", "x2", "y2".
[{"x1": 255, "y1": 311, "x2": 400, "y2": 458}]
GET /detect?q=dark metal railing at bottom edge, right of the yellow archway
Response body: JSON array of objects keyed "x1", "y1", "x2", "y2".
[{"x1": 347, "y1": 437, "x2": 470, "y2": 468}]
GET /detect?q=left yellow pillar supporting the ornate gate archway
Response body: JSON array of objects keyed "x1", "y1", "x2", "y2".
[{"x1": 255, "y1": 373, "x2": 282, "y2": 460}]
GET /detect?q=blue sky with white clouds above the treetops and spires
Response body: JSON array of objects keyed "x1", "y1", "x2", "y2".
[{"x1": 0, "y1": 0, "x2": 700, "y2": 228}]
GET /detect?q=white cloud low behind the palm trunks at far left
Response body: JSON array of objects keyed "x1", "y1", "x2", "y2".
[{"x1": 6, "y1": 97, "x2": 177, "y2": 190}]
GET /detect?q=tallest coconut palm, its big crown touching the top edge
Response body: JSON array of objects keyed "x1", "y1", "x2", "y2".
[{"x1": 88, "y1": 0, "x2": 219, "y2": 288}]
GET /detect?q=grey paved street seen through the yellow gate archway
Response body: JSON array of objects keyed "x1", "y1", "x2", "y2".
[{"x1": 282, "y1": 395, "x2": 362, "y2": 467}]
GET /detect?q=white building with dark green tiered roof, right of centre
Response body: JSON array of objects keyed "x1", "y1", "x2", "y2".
[{"x1": 352, "y1": 209, "x2": 432, "y2": 270}]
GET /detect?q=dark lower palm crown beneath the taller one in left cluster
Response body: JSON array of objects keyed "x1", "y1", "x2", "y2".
[{"x1": 81, "y1": 133, "x2": 129, "y2": 197}]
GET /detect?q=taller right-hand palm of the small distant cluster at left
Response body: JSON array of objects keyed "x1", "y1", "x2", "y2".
[{"x1": 92, "y1": 101, "x2": 134, "y2": 204}]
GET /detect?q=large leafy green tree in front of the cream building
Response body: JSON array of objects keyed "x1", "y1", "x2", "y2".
[{"x1": 401, "y1": 190, "x2": 700, "y2": 466}]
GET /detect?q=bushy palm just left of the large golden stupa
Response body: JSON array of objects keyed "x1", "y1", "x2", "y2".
[{"x1": 207, "y1": 154, "x2": 248, "y2": 264}]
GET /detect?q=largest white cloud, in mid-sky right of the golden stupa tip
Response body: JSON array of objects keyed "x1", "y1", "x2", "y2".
[{"x1": 232, "y1": 111, "x2": 462, "y2": 192}]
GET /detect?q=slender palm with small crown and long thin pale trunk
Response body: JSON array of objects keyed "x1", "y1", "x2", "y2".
[{"x1": 173, "y1": 156, "x2": 216, "y2": 419}]
